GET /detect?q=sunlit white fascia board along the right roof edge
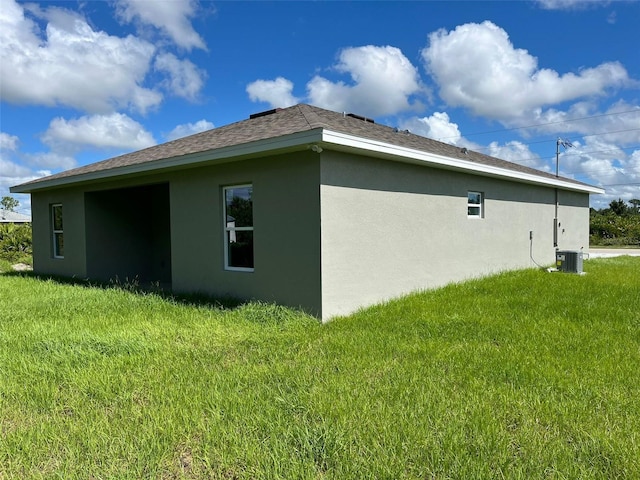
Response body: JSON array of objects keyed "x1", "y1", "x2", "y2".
[{"x1": 322, "y1": 130, "x2": 605, "y2": 194}]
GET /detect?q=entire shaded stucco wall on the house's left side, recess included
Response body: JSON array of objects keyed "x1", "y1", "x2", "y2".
[{"x1": 27, "y1": 151, "x2": 321, "y2": 315}]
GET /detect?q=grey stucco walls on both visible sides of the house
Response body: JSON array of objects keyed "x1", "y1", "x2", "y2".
[{"x1": 27, "y1": 149, "x2": 589, "y2": 320}]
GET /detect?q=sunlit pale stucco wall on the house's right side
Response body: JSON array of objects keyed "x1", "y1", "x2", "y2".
[{"x1": 321, "y1": 152, "x2": 588, "y2": 319}]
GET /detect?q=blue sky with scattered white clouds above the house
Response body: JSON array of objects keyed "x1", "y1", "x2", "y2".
[{"x1": 0, "y1": 0, "x2": 640, "y2": 213}]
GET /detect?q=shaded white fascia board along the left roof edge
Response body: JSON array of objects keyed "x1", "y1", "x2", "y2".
[{"x1": 10, "y1": 128, "x2": 322, "y2": 193}]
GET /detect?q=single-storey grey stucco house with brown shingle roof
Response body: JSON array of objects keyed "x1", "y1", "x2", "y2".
[{"x1": 11, "y1": 104, "x2": 603, "y2": 320}]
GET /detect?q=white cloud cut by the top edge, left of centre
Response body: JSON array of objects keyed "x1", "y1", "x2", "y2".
[{"x1": 116, "y1": 0, "x2": 207, "y2": 50}]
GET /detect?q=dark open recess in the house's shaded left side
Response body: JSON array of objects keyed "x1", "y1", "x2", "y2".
[{"x1": 84, "y1": 183, "x2": 171, "y2": 287}]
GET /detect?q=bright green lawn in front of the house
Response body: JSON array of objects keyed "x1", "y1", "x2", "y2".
[{"x1": 0, "y1": 257, "x2": 640, "y2": 480}]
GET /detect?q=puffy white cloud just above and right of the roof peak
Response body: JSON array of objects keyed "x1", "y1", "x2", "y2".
[{"x1": 307, "y1": 45, "x2": 424, "y2": 117}]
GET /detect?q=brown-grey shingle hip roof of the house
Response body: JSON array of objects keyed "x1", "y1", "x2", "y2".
[{"x1": 14, "y1": 104, "x2": 586, "y2": 189}]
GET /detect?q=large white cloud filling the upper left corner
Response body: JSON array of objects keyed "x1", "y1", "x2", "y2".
[{"x1": 0, "y1": 0, "x2": 162, "y2": 113}]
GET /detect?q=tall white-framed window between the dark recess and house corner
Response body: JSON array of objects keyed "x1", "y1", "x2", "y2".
[{"x1": 223, "y1": 185, "x2": 253, "y2": 272}]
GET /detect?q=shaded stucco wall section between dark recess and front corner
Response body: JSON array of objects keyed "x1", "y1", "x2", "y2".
[{"x1": 171, "y1": 152, "x2": 320, "y2": 314}]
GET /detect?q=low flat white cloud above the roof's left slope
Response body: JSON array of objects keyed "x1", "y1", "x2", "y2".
[{"x1": 42, "y1": 113, "x2": 156, "y2": 153}]
